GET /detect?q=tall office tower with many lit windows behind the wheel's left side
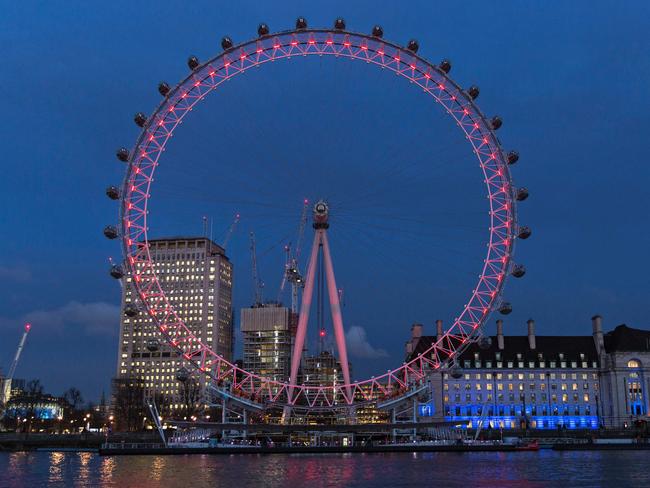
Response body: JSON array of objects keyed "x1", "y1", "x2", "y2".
[{"x1": 117, "y1": 237, "x2": 233, "y2": 411}]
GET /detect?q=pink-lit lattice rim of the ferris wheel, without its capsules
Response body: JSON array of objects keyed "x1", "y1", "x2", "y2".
[{"x1": 122, "y1": 29, "x2": 516, "y2": 408}]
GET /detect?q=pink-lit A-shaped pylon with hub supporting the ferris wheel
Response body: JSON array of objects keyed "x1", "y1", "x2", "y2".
[{"x1": 289, "y1": 200, "x2": 350, "y2": 402}]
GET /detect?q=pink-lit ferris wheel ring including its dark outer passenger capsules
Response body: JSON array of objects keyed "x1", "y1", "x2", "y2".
[{"x1": 104, "y1": 17, "x2": 531, "y2": 409}]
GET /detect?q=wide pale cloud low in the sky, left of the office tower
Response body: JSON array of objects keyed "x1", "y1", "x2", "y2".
[{"x1": 13, "y1": 301, "x2": 120, "y2": 335}]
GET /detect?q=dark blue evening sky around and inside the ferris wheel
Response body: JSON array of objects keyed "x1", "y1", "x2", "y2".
[{"x1": 0, "y1": 1, "x2": 650, "y2": 399}]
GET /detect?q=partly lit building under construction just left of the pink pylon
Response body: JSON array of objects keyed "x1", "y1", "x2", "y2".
[{"x1": 241, "y1": 304, "x2": 295, "y2": 381}]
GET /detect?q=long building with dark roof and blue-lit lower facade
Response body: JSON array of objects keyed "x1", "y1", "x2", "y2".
[{"x1": 406, "y1": 316, "x2": 650, "y2": 429}]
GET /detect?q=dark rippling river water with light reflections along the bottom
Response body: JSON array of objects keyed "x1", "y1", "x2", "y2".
[{"x1": 0, "y1": 450, "x2": 650, "y2": 488}]
